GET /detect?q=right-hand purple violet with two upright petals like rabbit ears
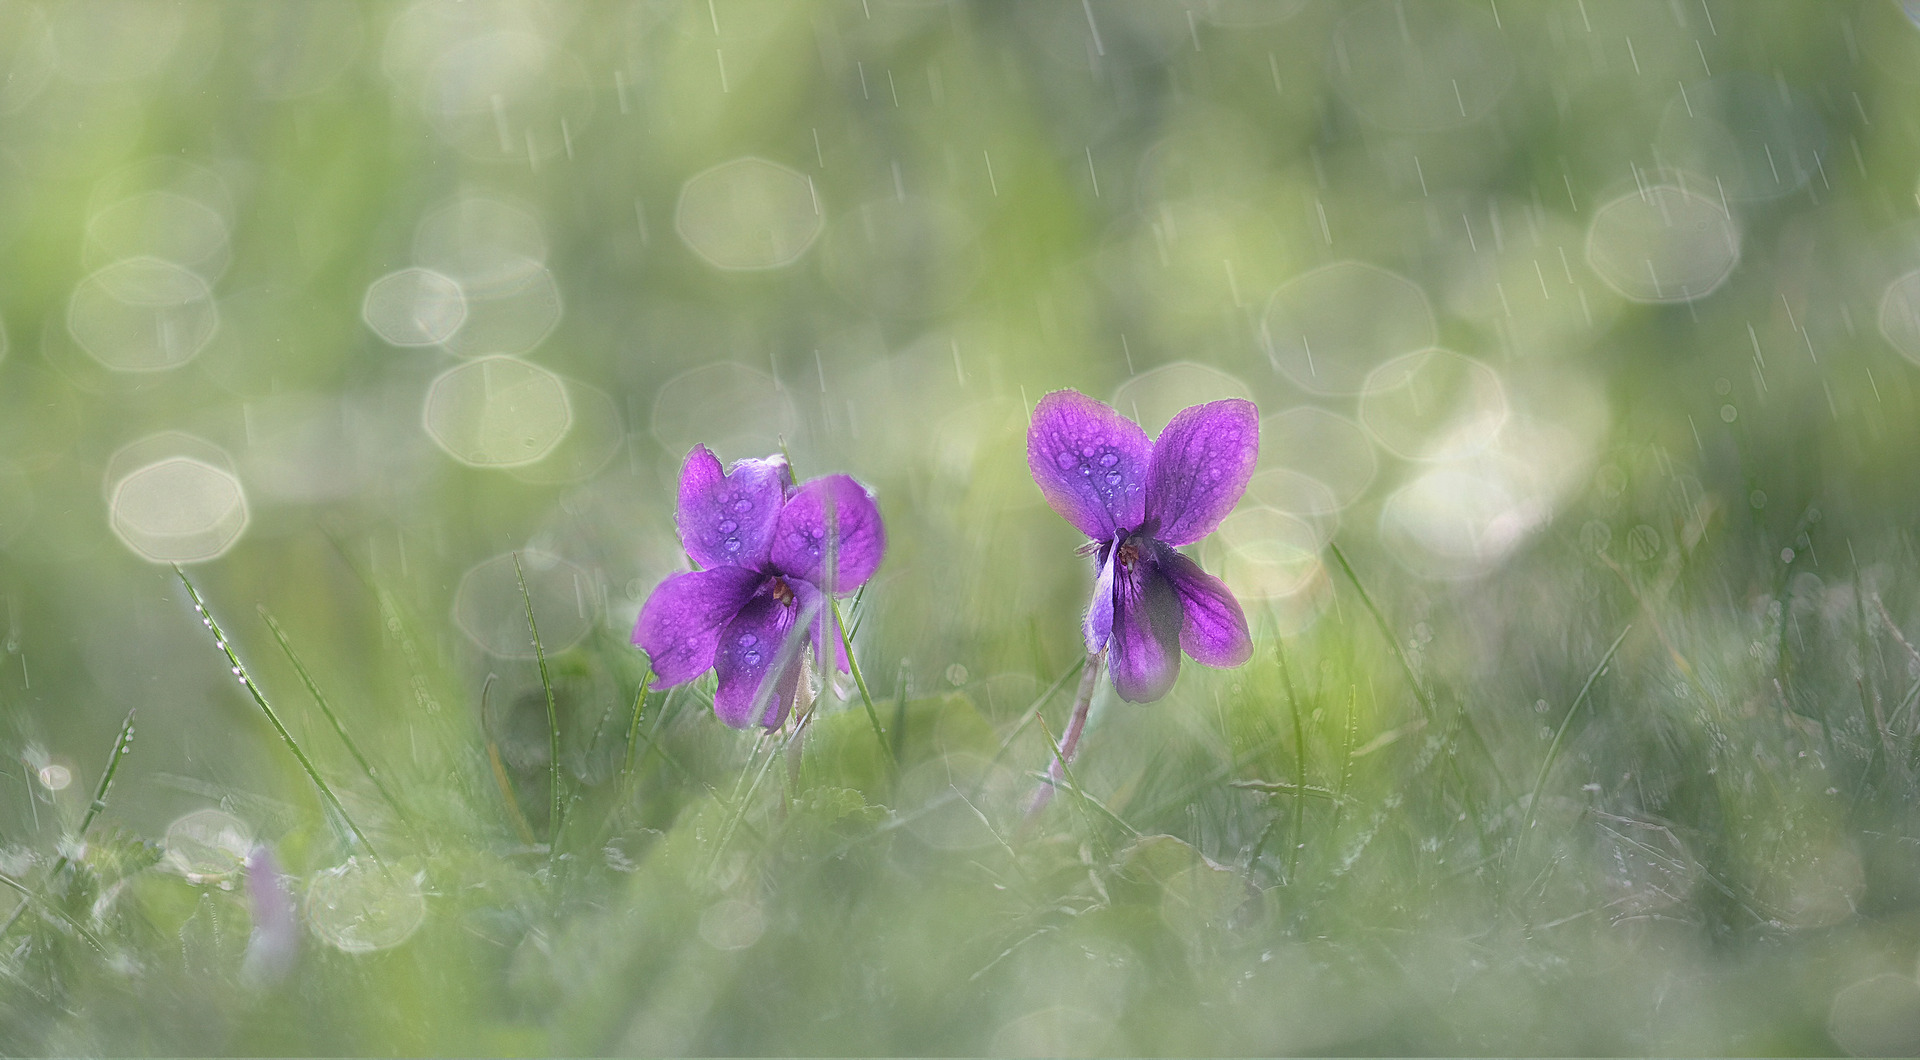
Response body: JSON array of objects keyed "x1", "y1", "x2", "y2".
[{"x1": 1027, "y1": 390, "x2": 1260, "y2": 703}]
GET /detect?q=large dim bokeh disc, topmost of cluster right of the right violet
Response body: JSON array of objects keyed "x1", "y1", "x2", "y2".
[{"x1": 1261, "y1": 261, "x2": 1438, "y2": 396}]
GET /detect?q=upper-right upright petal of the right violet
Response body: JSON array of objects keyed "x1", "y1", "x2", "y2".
[{"x1": 1146, "y1": 398, "x2": 1260, "y2": 547}]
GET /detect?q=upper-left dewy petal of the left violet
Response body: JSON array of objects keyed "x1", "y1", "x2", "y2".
[{"x1": 674, "y1": 446, "x2": 791, "y2": 568}]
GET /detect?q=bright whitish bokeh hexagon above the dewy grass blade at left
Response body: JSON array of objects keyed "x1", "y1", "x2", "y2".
[{"x1": 108, "y1": 455, "x2": 248, "y2": 563}]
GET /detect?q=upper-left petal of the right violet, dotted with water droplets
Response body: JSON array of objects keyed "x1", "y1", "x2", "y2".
[{"x1": 1027, "y1": 390, "x2": 1152, "y2": 542}]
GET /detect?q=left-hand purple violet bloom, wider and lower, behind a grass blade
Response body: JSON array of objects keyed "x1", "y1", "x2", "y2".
[{"x1": 634, "y1": 446, "x2": 887, "y2": 728}]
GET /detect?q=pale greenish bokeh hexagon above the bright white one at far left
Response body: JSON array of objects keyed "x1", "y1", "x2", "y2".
[{"x1": 67, "y1": 257, "x2": 221, "y2": 373}]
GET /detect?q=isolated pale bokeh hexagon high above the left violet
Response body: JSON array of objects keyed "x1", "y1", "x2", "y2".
[{"x1": 674, "y1": 157, "x2": 826, "y2": 269}]
